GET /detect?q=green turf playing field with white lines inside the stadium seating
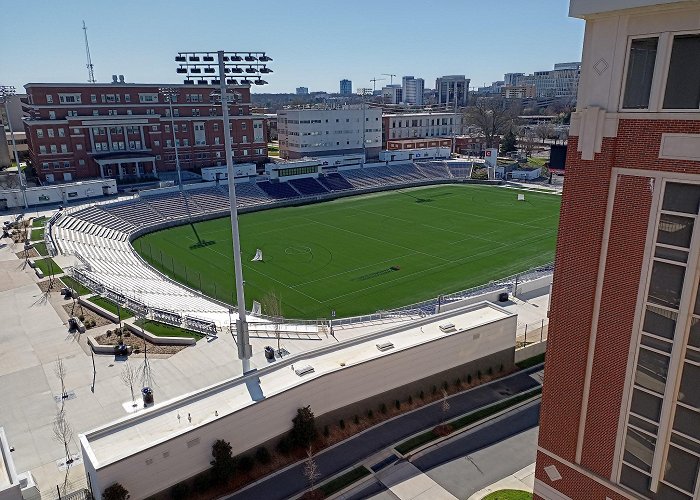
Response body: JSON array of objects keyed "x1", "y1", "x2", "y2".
[{"x1": 134, "y1": 185, "x2": 560, "y2": 319}]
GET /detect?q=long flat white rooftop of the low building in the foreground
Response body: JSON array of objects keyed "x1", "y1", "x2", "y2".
[{"x1": 81, "y1": 302, "x2": 515, "y2": 467}]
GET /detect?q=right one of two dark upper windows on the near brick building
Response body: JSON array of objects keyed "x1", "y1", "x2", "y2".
[{"x1": 664, "y1": 35, "x2": 700, "y2": 109}]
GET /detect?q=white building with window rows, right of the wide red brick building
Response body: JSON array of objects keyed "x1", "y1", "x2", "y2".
[{"x1": 277, "y1": 106, "x2": 382, "y2": 160}]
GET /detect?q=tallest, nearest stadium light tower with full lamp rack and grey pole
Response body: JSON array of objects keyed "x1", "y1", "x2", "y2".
[{"x1": 175, "y1": 50, "x2": 272, "y2": 373}]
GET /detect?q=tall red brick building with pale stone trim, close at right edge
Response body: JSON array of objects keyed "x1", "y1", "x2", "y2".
[{"x1": 535, "y1": 0, "x2": 700, "y2": 500}]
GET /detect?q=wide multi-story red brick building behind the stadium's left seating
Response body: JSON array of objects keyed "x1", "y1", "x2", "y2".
[{"x1": 24, "y1": 78, "x2": 267, "y2": 182}]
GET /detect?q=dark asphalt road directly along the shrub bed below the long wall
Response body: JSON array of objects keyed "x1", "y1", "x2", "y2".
[{"x1": 224, "y1": 368, "x2": 541, "y2": 500}]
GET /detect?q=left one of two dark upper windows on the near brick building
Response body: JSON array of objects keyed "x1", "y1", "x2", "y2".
[{"x1": 622, "y1": 37, "x2": 659, "y2": 109}]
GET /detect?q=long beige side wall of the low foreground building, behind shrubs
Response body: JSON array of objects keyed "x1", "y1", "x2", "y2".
[{"x1": 85, "y1": 310, "x2": 517, "y2": 498}]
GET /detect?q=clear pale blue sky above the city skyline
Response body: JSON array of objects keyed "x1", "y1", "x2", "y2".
[{"x1": 0, "y1": 0, "x2": 584, "y2": 92}]
